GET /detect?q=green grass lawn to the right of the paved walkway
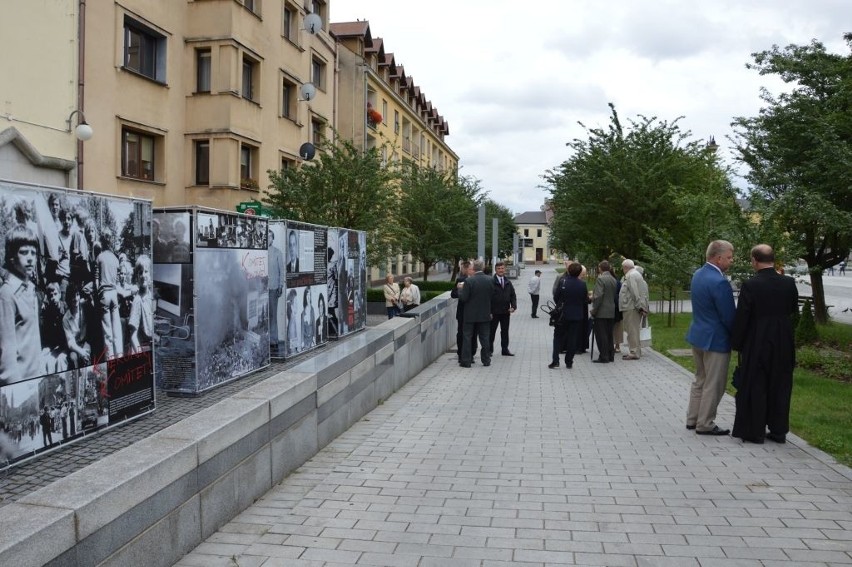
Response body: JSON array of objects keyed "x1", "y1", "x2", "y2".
[{"x1": 650, "y1": 313, "x2": 852, "y2": 466}]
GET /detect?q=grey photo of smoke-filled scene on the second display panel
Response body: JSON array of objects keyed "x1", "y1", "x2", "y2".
[{"x1": 195, "y1": 249, "x2": 269, "y2": 392}]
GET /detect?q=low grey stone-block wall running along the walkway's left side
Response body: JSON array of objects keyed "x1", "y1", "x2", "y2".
[{"x1": 0, "y1": 293, "x2": 456, "y2": 567}]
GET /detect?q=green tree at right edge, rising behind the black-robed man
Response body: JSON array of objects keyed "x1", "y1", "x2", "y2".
[{"x1": 732, "y1": 34, "x2": 852, "y2": 323}]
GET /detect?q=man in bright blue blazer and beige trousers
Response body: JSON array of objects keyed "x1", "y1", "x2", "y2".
[{"x1": 686, "y1": 240, "x2": 736, "y2": 435}]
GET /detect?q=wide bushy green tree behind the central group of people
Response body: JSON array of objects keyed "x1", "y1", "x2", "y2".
[{"x1": 544, "y1": 104, "x2": 738, "y2": 259}]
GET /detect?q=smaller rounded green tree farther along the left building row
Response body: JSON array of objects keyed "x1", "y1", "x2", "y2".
[{"x1": 399, "y1": 163, "x2": 476, "y2": 281}]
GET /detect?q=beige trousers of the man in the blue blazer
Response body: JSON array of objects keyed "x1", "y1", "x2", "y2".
[{"x1": 686, "y1": 347, "x2": 731, "y2": 431}]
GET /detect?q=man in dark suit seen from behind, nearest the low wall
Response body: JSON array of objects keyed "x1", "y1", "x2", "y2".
[{"x1": 459, "y1": 260, "x2": 494, "y2": 368}]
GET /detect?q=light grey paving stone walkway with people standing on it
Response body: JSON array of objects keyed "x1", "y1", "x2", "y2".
[{"x1": 177, "y1": 267, "x2": 852, "y2": 567}]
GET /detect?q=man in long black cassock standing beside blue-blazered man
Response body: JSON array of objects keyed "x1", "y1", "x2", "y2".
[{"x1": 731, "y1": 244, "x2": 798, "y2": 443}]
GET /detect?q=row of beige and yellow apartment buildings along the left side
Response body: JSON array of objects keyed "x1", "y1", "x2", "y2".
[{"x1": 0, "y1": 0, "x2": 458, "y2": 237}]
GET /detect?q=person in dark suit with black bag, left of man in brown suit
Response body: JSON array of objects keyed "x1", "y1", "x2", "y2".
[{"x1": 547, "y1": 262, "x2": 589, "y2": 368}]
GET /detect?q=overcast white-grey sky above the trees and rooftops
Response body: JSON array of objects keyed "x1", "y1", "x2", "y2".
[{"x1": 330, "y1": 0, "x2": 852, "y2": 213}]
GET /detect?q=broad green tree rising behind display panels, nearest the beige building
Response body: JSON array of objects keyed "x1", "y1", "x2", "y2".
[{"x1": 265, "y1": 138, "x2": 400, "y2": 265}]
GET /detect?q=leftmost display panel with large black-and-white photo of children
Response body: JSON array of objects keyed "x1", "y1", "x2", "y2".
[{"x1": 0, "y1": 182, "x2": 154, "y2": 468}]
